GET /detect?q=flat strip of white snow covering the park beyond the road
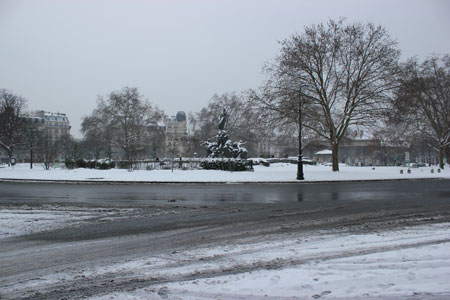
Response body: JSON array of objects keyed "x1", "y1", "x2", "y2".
[{"x1": 0, "y1": 163, "x2": 450, "y2": 182}]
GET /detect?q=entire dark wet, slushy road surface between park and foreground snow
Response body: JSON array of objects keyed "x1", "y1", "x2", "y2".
[{"x1": 0, "y1": 180, "x2": 450, "y2": 299}]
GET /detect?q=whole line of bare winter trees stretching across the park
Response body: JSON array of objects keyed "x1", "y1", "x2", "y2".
[{"x1": 0, "y1": 19, "x2": 450, "y2": 171}]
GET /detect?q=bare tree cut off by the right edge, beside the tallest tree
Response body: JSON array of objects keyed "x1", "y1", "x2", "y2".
[{"x1": 394, "y1": 55, "x2": 450, "y2": 168}]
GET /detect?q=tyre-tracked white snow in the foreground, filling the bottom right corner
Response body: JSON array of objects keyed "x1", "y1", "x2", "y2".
[{"x1": 86, "y1": 223, "x2": 450, "y2": 300}]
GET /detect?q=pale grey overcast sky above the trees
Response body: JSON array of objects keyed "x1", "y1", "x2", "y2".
[{"x1": 0, "y1": 0, "x2": 450, "y2": 137}]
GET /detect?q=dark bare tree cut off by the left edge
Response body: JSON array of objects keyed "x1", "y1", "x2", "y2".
[{"x1": 0, "y1": 89, "x2": 26, "y2": 162}]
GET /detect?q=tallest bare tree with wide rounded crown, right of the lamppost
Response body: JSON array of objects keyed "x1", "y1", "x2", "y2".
[{"x1": 256, "y1": 19, "x2": 400, "y2": 171}]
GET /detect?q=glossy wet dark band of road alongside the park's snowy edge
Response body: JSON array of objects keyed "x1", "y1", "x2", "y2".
[{"x1": 0, "y1": 180, "x2": 450, "y2": 208}]
